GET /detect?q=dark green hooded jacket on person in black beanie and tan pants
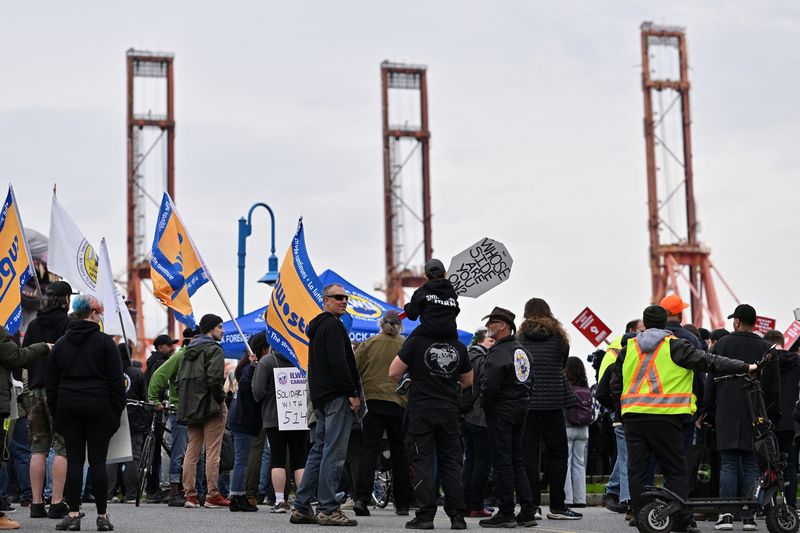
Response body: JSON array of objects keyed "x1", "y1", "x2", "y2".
[{"x1": 176, "y1": 335, "x2": 225, "y2": 425}]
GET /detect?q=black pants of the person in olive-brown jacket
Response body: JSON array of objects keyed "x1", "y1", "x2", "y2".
[{"x1": 355, "y1": 412, "x2": 411, "y2": 508}]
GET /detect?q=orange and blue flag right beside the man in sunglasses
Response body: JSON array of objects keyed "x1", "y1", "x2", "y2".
[{"x1": 267, "y1": 218, "x2": 323, "y2": 370}]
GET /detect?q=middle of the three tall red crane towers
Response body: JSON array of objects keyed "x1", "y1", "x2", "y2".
[{"x1": 381, "y1": 61, "x2": 433, "y2": 306}]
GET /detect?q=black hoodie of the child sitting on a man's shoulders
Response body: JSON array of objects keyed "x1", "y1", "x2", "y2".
[{"x1": 403, "y1": 278, "x2": 461, "y2": 339}]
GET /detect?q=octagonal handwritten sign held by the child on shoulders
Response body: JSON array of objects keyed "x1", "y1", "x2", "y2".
[{"x1": 447, "y1": 238, "x2": 514, "y2": 298}]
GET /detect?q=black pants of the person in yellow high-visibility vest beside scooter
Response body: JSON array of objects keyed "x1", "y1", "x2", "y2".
[{"x1": 625, "y1": 420, "x2": 691, "y2": 529}]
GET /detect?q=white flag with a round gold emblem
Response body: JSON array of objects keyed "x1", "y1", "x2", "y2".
[{"x1": 47, "y1": 193, "x2": 97, "y2": 295}]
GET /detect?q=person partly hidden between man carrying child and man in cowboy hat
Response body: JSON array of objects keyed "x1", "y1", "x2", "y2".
[{"x1": 461, "y1": 328, "x2": 494, "y2": 518}]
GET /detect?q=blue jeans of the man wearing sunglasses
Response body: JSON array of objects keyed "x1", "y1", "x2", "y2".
[{"x1": 294, "y1": 396, "x2": 354, "y2": 514}]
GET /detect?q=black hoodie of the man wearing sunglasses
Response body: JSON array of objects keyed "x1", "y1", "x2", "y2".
[{"x1": 306, "y1": 311, "x2": 361, "y2": 409}]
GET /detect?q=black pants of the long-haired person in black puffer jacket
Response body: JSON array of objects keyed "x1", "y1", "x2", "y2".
[{"x1": 523, "y1": 409, "x2": 569, "y2": 511}]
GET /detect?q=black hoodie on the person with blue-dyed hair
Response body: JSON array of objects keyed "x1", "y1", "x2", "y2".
[{"x1": 47, "y1": 320, "x2": 126, "y2": 417}]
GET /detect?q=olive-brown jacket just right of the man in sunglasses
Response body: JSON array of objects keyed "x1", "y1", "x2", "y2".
[{"x1": 356, "y1": 332, "x2": 408, "y2": 407}]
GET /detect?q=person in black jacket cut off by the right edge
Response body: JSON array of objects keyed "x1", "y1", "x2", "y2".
[{"x1": 764, "y1": 329, "x2": 800, "y2": 509}]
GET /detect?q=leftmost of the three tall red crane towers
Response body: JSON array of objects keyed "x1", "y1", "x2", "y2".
[{"x1": 126, "y1": 49, "x2": 175, "y2": 359}]
